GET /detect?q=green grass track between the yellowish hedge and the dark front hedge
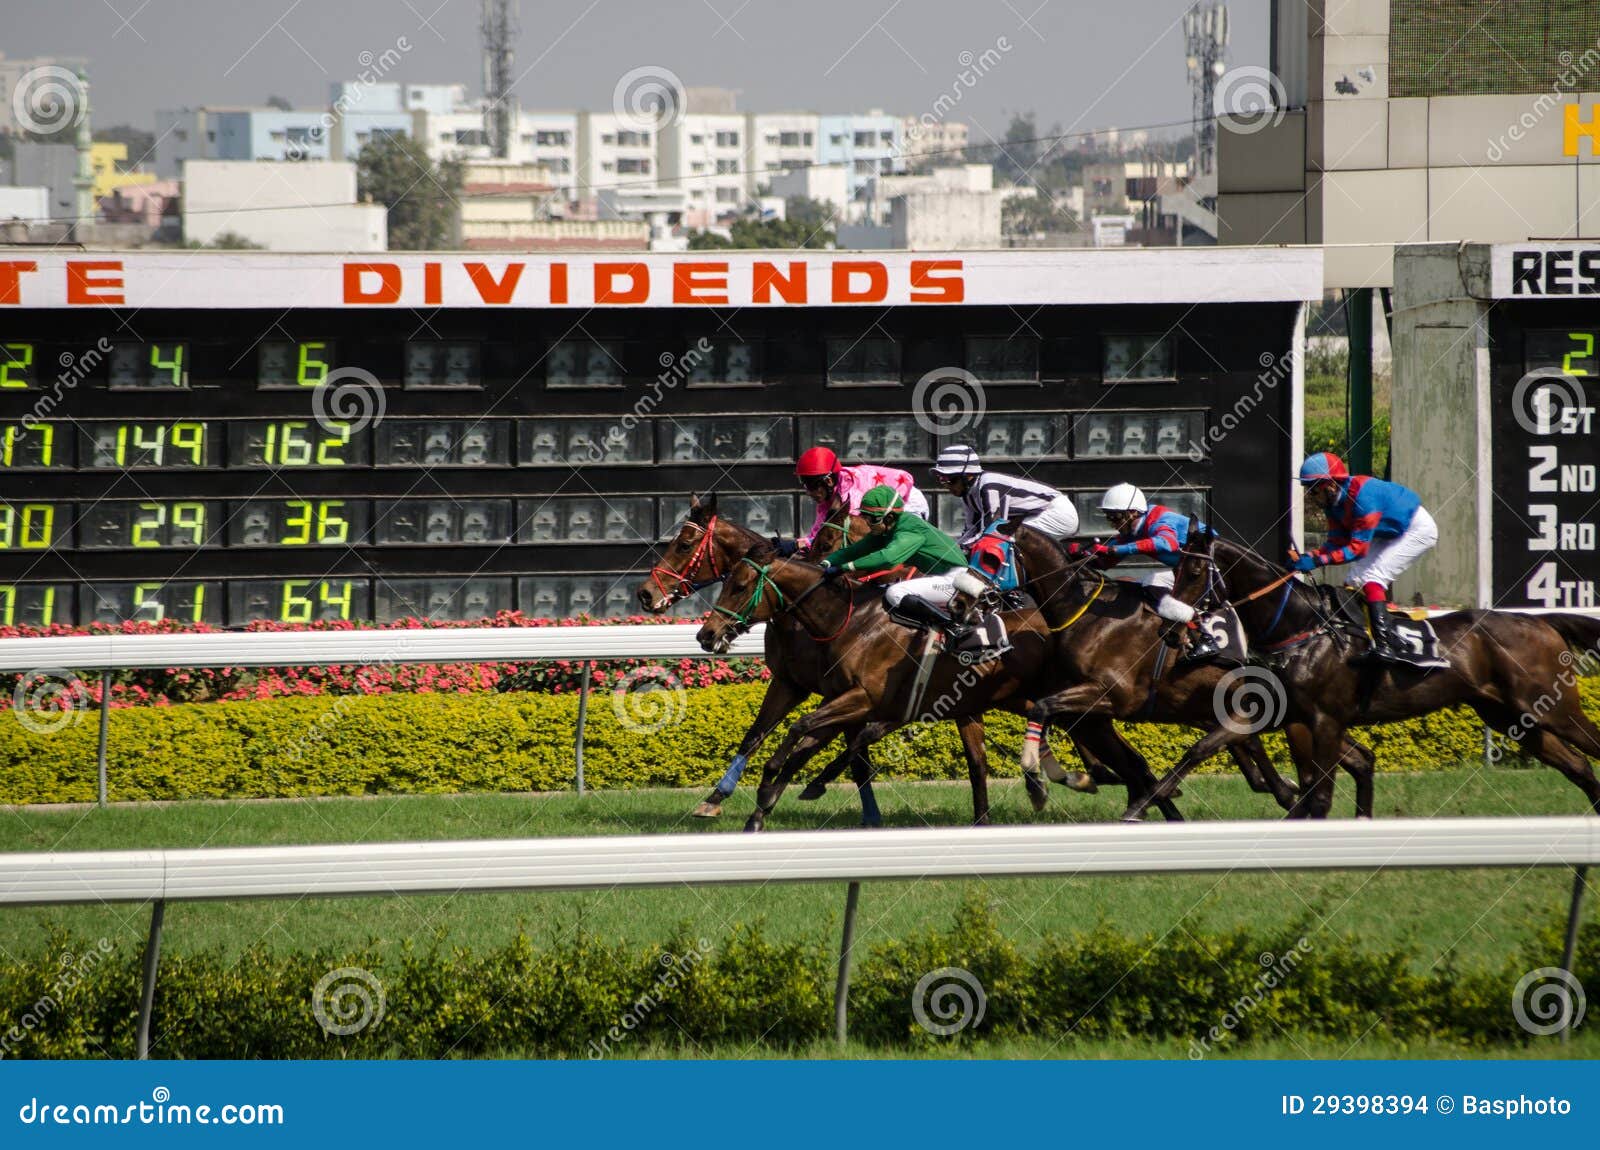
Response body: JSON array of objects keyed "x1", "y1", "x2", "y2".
[{"x1": 0, "y1": 768, "x2": 1586, "y2": 968}]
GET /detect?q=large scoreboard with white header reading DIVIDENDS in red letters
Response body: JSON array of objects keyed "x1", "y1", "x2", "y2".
[{"x1": 0, "y1": 250, "x2": 1322, "y2": 625}]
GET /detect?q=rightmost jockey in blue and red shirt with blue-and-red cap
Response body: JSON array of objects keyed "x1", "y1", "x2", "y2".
[{"x1": 1290, "y1": 451, "x2": 1438, "y2": 664}]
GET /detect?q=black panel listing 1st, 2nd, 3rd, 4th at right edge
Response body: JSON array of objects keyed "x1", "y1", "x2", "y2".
[{"x1": 1490, "y1": 299, "x2": 1600, "y2": 608}]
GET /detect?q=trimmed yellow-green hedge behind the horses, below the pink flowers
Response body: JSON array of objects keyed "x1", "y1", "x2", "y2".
[{"x1": 0, "y1": 678, "x2": 1574, "y2": 803}]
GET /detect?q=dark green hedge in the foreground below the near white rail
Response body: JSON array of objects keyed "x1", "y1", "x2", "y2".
[{"x1": 0, "y1": 904, "x2": 1600, "y2": 1059}]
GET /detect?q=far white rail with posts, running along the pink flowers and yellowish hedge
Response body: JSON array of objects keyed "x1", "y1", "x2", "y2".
[{"x1": 0, "y1": 622, "x2": 765, "y2": 806}]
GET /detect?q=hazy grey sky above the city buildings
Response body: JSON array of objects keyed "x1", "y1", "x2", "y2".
[{"x1": 0, "y1": 0, "x2": 1267, "y2": 142}]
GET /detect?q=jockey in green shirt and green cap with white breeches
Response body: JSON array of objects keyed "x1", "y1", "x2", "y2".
[{"x1": 822, "y1": 485, "x2": 986, "y2": 641}]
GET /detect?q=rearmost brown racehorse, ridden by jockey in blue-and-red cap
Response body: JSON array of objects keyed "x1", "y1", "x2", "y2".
[{"x1": 1174, "y1": 534, "x2": 1600, "y2": 817}]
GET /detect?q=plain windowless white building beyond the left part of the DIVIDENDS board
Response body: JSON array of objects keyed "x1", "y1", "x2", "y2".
[{"x1": 182, "y1": 160, "x2": 389, "y2": 251}]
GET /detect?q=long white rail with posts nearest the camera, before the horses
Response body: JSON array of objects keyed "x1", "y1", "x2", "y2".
[{"x1": 0, "y1": 816, "x2": 1600, "y2": 1057}]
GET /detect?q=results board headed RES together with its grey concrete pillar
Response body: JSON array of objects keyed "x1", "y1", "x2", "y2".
[{"x1": 1394, "y1": 243, "x2": 1600, "y2": 609}]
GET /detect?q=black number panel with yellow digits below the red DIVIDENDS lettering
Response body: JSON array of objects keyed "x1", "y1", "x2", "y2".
[{"x1": 0, "y1": 304, "x2": 1296, "y2": 625}]
